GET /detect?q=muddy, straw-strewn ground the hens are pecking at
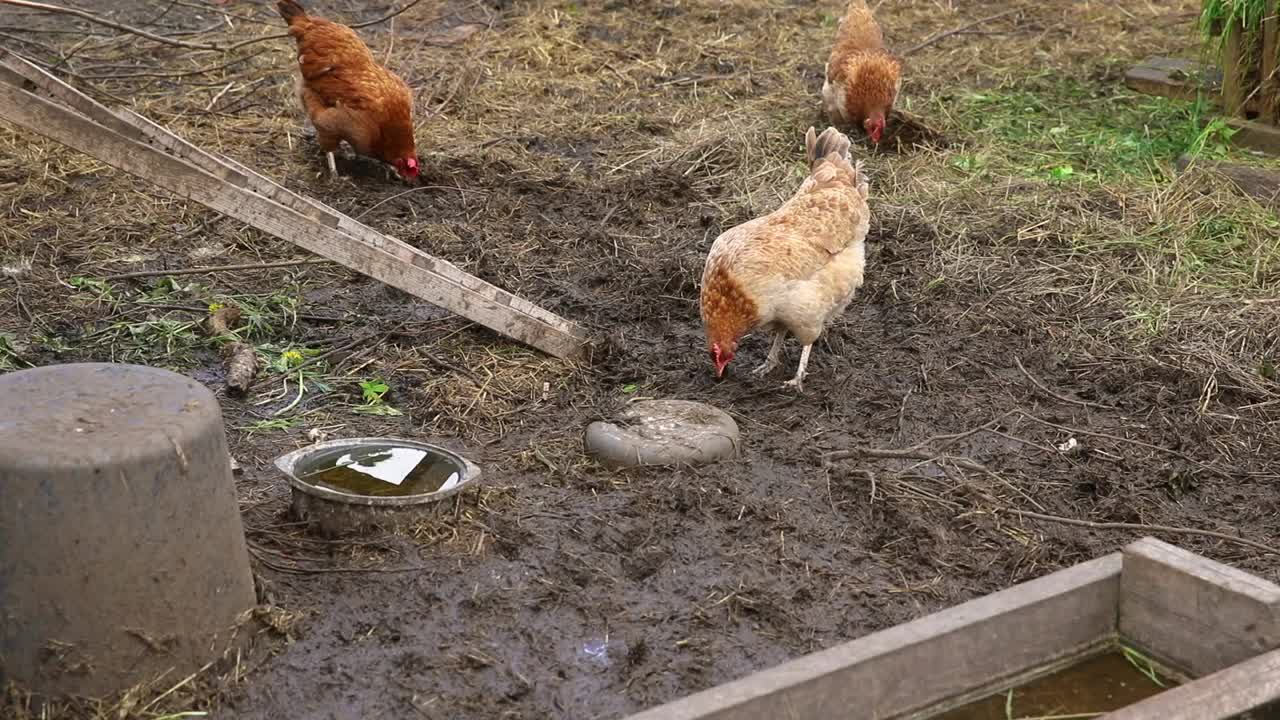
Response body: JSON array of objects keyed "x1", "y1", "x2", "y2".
[{"x1": 0, "y1": 0, "x2": 1280, "y2": 719}]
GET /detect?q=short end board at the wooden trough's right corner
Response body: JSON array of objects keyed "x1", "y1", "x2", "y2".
[{"x1": 1120, "y1": 538, "x2": 1280, "y2": 676}]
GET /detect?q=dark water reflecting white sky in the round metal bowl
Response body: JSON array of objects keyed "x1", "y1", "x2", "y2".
[{"x1": 298, "y1": 445, "x2": 462, "y2": 497}]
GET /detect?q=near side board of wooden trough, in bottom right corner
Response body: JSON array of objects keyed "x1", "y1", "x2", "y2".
[{"x1": 1098, "y1": 651, "x2": 1280, "y2": 720}]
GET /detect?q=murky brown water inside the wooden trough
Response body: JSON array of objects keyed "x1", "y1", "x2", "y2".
[{"x1": 929, "y1": 651, "x2": 1178, "y2": 720}]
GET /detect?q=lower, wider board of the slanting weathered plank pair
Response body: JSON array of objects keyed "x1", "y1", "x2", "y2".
[{"x1": 0, "y1": 83, "x2": 584, "y2": 357}]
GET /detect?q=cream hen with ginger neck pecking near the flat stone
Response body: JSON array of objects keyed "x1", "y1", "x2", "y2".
[{"x1": 701, "y1": 128, "x2": 870, "y2": 391}]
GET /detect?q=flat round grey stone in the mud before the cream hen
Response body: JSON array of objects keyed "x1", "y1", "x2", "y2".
[{"x1": 584, "y1": 400, "x2": 739, "y2": 466}]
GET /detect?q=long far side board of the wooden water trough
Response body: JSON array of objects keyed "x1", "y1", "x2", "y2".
[{"x1": 628, "y1": 553, "x2": 1121, "y2": 720}]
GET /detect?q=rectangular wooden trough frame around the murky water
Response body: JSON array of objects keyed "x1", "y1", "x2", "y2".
[{"x1": 627, "y1": 538, "x2": 1280, "y2": 720}]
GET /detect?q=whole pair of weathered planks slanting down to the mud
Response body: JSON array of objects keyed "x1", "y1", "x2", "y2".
[{"x1": 0, "y1": 55, "x2": 586, "y2": 357}]
